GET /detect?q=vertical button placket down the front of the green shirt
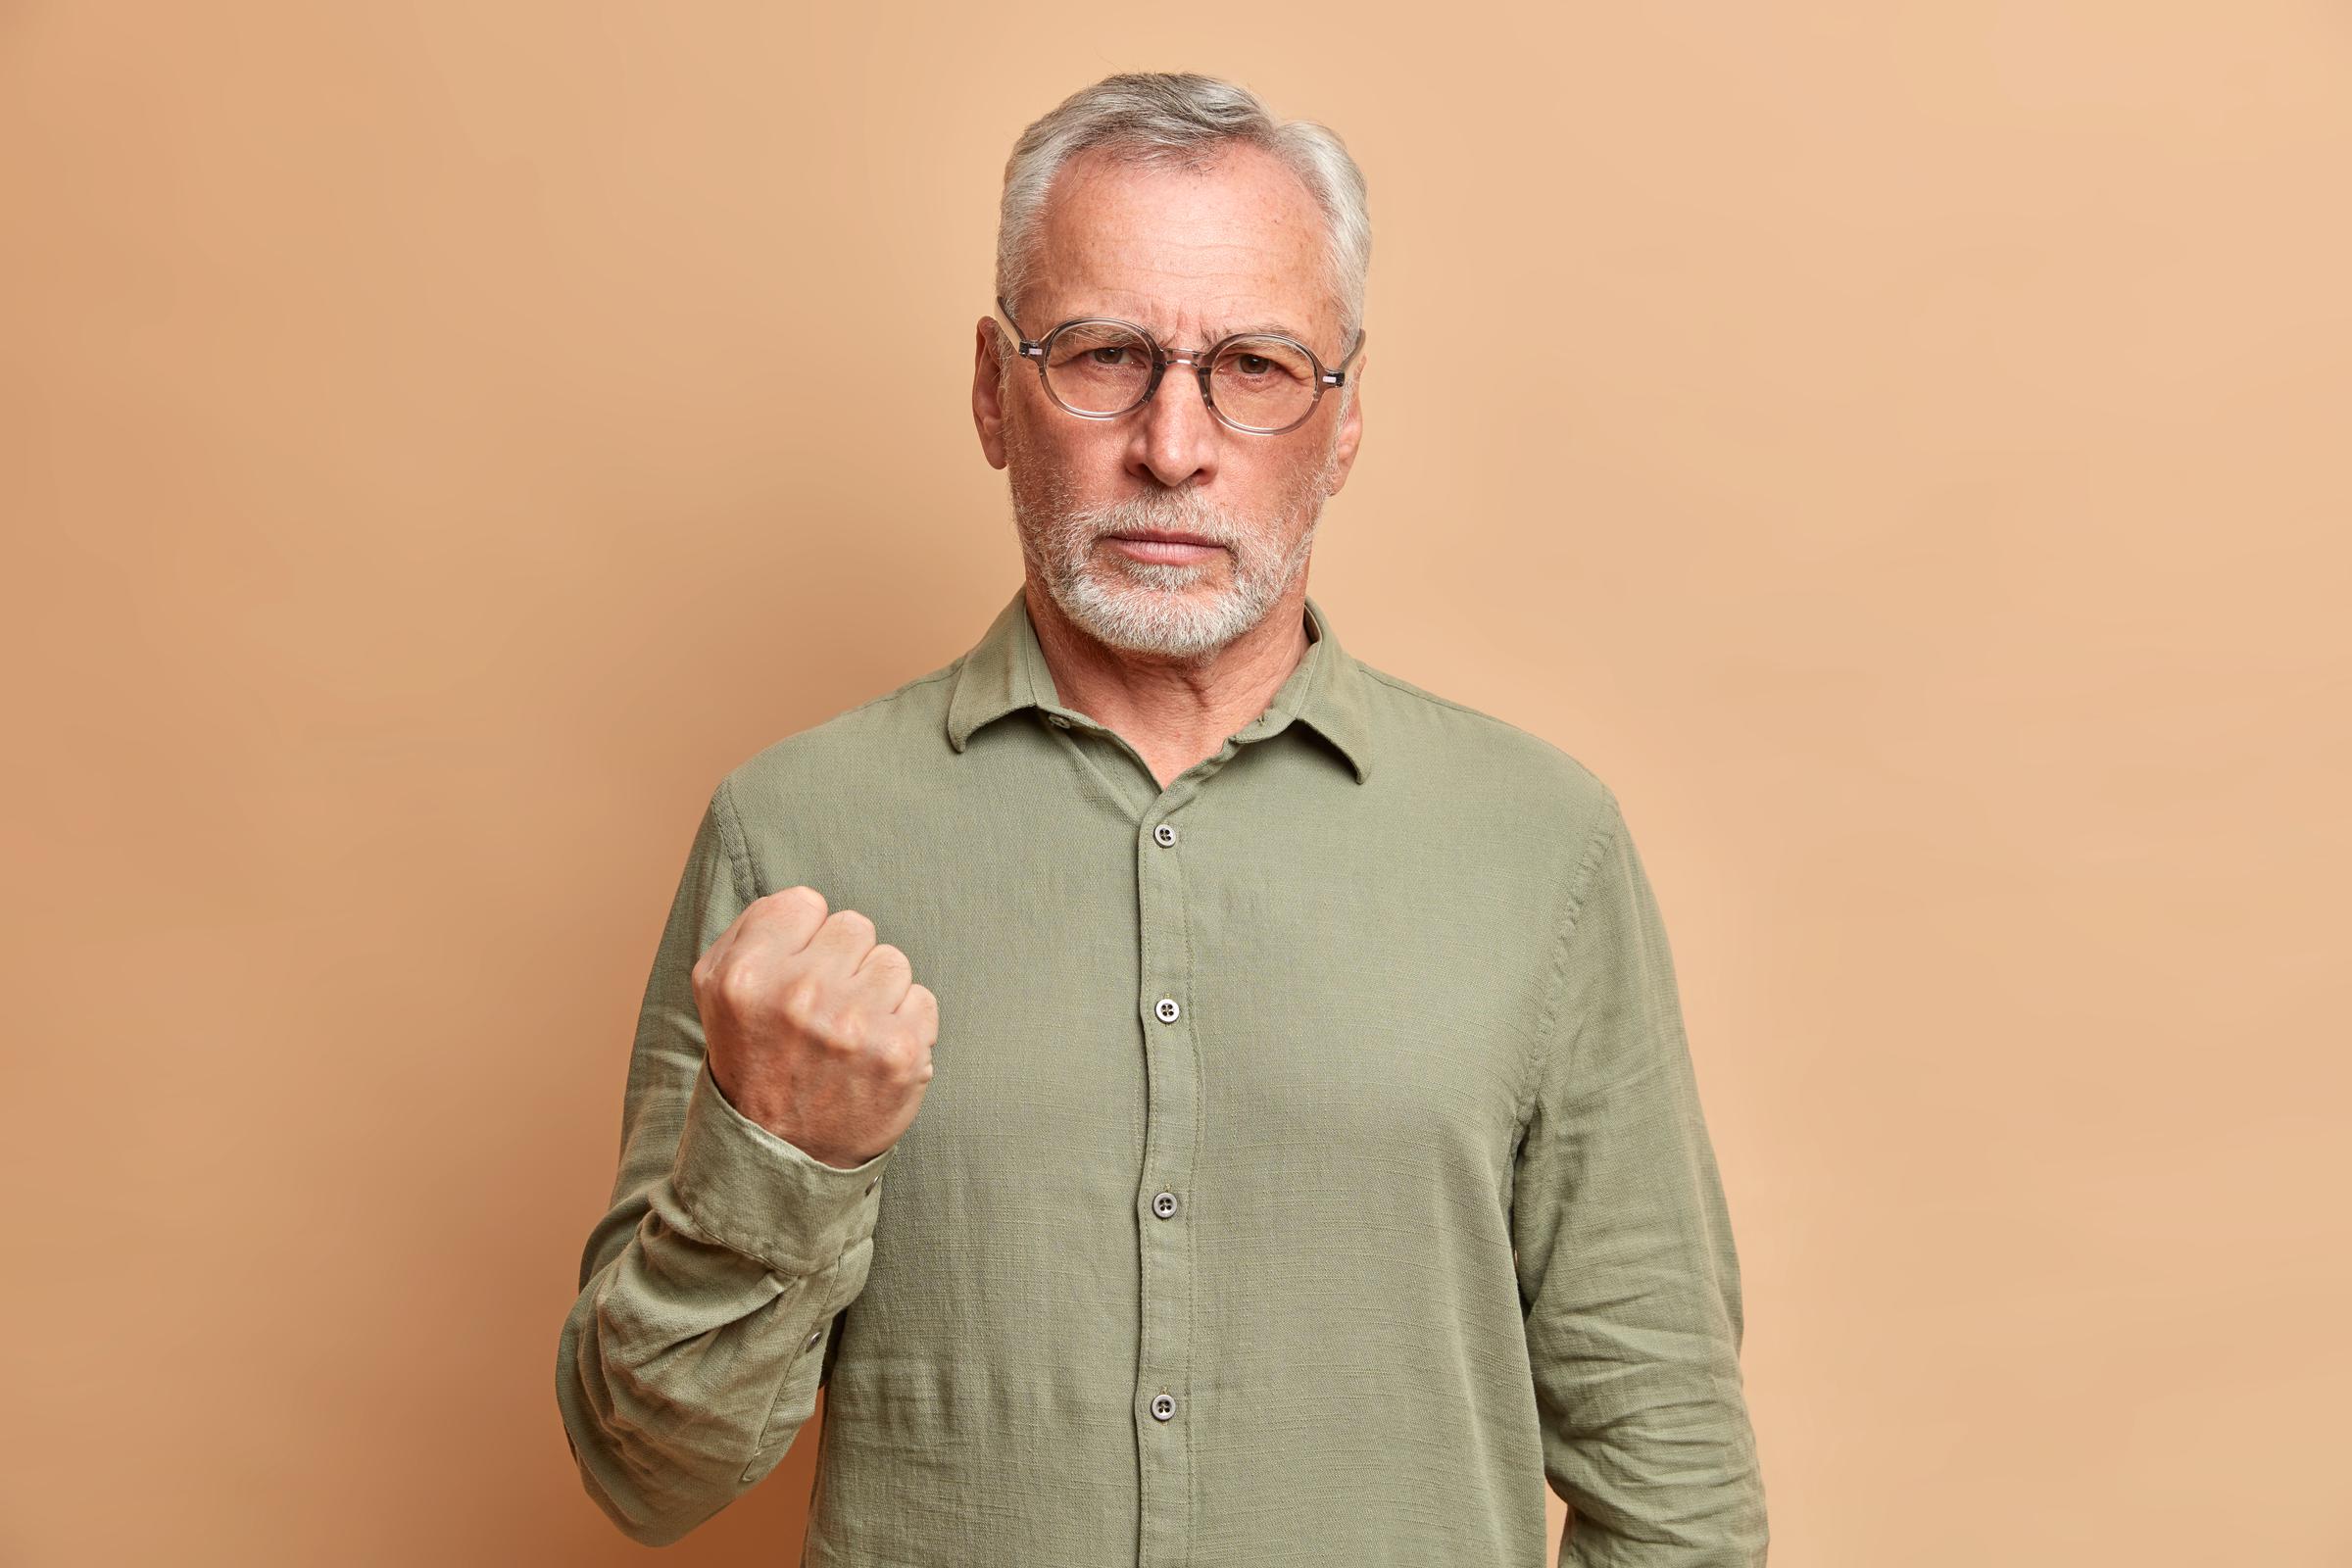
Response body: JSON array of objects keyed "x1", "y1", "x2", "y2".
[{"x1": 1134, "y1": 804, "x2": 1200, "y2": 1568}]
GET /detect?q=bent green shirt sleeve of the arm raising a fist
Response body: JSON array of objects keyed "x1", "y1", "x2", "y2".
[{"x1": 555, "y1": 780, "x2": 892, "y2": 1546}]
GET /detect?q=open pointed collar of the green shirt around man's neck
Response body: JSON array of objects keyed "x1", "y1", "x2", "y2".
[{"x1": 948, "y1": 583, "x2": 1371, "y2": 783}]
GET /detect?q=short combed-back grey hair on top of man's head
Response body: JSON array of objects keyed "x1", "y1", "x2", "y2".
[{"x1": 998, "y1": 71, "x2": 1371, "y2": 371}]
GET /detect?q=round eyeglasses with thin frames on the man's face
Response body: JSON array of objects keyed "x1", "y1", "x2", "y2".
[{"x1": 998, "y1": 296, "x2": 1364, "y2": 435}]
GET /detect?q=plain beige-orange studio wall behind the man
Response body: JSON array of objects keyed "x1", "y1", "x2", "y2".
[{"x1": 0, "y1": 0, "x2": 2352, "y2": 1568}]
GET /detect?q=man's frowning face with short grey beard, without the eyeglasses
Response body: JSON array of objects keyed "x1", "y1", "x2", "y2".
[{"x1": 974, "y1": 148, "x2": 1364, "y2": 659}]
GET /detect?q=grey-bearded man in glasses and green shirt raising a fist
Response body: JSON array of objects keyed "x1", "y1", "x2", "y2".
[{"x1": 558, "y1": 75, "x2": 1766, "y2": 1568}]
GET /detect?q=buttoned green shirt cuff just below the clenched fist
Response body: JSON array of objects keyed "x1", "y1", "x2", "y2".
[{"x1": 670, "y1": 1055, "x2": 896, "y2": 1277}]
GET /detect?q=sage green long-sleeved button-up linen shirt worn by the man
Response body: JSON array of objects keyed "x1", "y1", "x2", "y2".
[{"x1": 558, "y1": 582, "x2": 1766, "y2": 1568}]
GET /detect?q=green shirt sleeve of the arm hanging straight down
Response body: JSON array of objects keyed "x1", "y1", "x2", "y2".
[{"x1": 1512, "y1": 795, "x2": 1766, "y2": 1568}]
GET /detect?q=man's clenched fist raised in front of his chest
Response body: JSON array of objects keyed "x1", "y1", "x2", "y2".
[{"x1": 694, "y1": 886, "x2": 939, "y2": 1168}]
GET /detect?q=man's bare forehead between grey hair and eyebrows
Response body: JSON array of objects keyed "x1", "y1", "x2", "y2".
[{"x1": 1023, "y1": 146, "x2": 1343, "y2": 358}]
